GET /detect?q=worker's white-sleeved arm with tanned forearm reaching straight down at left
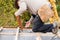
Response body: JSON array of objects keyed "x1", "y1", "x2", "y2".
[{"x1": 15, "y1": 2, "x2": 27, "y2": 29}]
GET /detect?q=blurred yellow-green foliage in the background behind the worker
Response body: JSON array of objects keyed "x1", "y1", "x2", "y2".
[{"x1": 0, "y1": 0, "x2": 60, "y2": 27}]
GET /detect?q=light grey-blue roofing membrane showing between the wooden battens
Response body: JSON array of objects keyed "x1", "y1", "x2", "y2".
[{"x1": 0, "y1": 29, "x2": 60, "y2": 40}]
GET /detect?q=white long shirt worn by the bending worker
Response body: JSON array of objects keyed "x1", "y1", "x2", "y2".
[{"x1": 15, "y1": 0, "x2": 51, "y2": 19}]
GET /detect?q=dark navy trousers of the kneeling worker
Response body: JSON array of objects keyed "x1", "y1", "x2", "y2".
[{"x1": 32, "y1": 16, "x2": 54, "y2": 33}]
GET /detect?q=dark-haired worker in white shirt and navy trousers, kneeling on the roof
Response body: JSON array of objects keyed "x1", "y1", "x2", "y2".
[{"x1": 15, "y1": 0, "x2": 57, "y2": 33}]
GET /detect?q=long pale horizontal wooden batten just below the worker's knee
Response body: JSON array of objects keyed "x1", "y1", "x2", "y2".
[{"x1": 0, "y1": 33, "x2": 57, "y2": 36}]
